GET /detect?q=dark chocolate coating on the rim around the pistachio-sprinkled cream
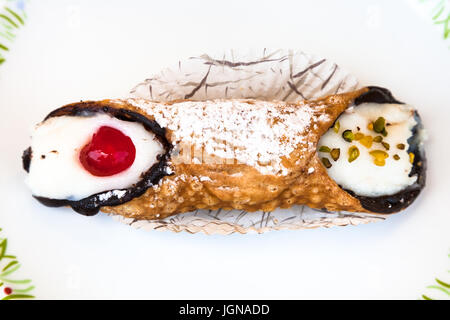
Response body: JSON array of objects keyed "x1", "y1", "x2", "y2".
[{"x1": 345, "y1": 86, "x2": 426, "y2": 214}]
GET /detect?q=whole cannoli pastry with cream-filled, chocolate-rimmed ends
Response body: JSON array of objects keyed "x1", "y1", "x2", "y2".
[{"x1": 23, "y1": 87, "x2": 426, "y2": 219}]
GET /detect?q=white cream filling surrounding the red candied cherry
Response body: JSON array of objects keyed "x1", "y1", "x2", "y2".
[{"x1": 26, "y1": 114, "x2": 164, "y2": 200}]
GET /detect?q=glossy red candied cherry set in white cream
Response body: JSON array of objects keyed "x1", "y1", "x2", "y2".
[{"x1": 79, "y1": 126, "x2": 136, "y2": 177}]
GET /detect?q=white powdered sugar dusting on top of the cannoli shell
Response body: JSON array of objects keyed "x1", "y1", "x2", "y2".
[{"x1": 128, "y1": 99, "x2": 327, "y2": 175}]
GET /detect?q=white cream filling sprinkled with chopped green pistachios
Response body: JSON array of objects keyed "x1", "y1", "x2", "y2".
[{"x1": 318, "y1": 103, "x2": 417, "y2": 197}]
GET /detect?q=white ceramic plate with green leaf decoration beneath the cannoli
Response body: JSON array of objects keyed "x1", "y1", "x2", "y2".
[{"x1": 0, "y1": 0, "x2": 450, "y2": 299}]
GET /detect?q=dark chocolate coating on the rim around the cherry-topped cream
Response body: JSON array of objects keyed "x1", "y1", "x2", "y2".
[{"x1": 22, "y1": 102, "x2": 172, "y2": 216}]
